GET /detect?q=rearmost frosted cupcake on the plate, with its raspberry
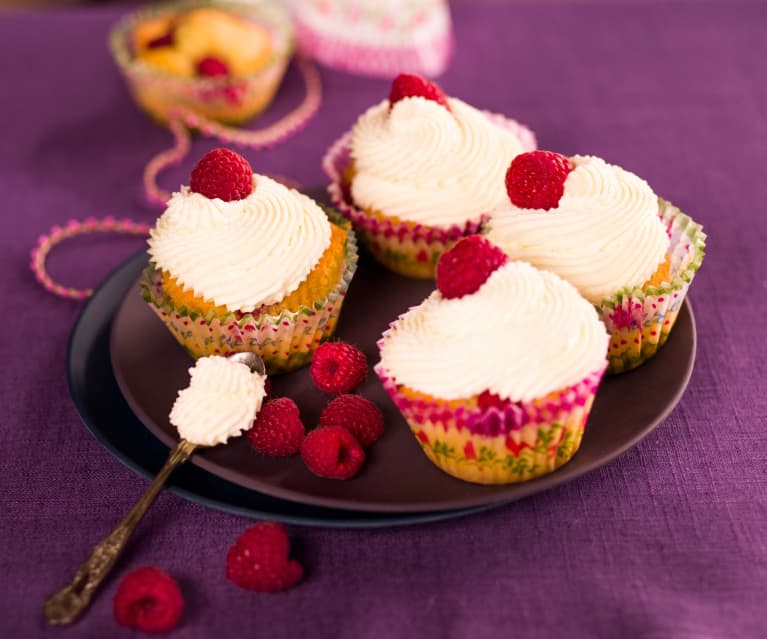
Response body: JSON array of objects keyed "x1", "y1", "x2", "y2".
[{"x1": 323, "y1": 75, "x2": 535, "y2": 278}]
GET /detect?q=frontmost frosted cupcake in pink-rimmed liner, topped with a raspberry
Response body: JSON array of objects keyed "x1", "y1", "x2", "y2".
[{"x1": 375, "y1": 235, "x2": 608, "y2": 484}]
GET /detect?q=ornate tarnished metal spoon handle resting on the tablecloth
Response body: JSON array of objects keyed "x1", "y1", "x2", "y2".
[{"x1": 43, "y1": 439, "x2": 196, "y2": 624}]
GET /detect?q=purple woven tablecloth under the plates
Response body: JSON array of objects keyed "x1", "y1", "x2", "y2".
[{"x1": 0, "y1": 1, "x2": 767, "y2": 639}]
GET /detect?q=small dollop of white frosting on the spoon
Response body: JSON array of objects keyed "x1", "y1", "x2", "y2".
[{"x1": 170, "y1": 355, "x2": 266, "y2": 446}]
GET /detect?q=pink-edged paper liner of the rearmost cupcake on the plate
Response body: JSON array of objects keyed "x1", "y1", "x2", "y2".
[{"x1": 322, "y1": 113, "x2": 536, "y2": 279}]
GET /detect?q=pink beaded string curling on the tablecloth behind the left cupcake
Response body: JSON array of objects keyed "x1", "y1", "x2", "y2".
[{"x1": 30, "y1": 56, "x2": 322, "y2": 300}]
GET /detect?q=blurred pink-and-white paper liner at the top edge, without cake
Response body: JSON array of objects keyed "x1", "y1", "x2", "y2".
[{"x1": 295, "y1": 3, "x2": 455, "y2": 78}]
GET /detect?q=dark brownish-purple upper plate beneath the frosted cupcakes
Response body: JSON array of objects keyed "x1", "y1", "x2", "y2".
[{"x1": 111, "y1": 241, "x2": 696, "y2": 513}]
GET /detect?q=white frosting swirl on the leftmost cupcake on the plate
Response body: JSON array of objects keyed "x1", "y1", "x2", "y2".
[{"x1": 149, "y1": 175, "x2": 330, "y2": 313}]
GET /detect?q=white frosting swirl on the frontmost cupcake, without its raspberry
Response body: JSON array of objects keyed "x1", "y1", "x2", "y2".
[{"x1": 381, "y1": 262, "x2": 609, "y2": 401}]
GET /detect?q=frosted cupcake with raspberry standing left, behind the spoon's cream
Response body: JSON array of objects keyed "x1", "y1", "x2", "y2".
[{"x1": 140, "y1": 149, "x2": 357, "y2": 373}]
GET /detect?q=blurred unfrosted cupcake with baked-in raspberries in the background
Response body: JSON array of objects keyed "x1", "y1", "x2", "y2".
[{"x1": 110, "y1": 1, "x2": 293, "y2": 124}]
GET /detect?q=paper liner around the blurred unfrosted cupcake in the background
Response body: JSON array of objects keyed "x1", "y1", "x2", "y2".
[{"x1": 109, "y1": 0, "x2": 293, "y2": 124}]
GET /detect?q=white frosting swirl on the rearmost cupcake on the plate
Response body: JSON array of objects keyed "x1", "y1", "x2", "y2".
[{"x1": 351, "y1": 97, "x2": 524, "y2": 227}]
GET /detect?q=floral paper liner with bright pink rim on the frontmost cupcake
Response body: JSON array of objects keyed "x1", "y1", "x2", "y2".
[{"x1": 375, "y1": 363, "x2": 605, "y2": 484}]
